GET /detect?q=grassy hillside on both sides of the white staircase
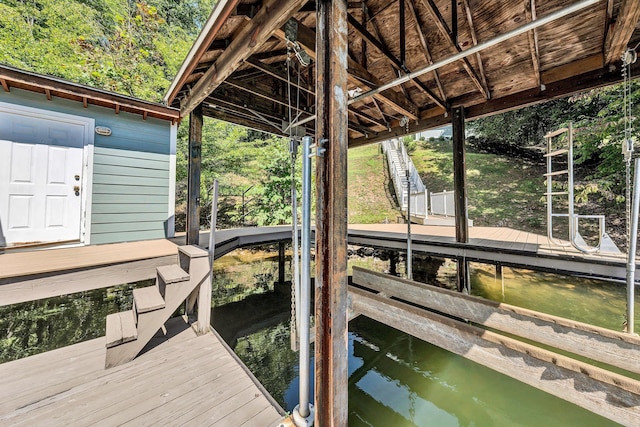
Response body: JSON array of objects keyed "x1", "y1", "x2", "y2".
[{"x1": 349, "y1": 141, "x2": 545, "y2": 234}]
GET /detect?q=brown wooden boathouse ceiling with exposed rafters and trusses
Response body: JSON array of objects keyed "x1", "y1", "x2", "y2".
[{"x1": 166, "y1": 0, "x2": 640, "y2": 146}]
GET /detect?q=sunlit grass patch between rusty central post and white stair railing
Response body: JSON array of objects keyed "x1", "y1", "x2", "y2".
[{"x1": 347, "y1": 144, "x2": 400, "y2": 224}]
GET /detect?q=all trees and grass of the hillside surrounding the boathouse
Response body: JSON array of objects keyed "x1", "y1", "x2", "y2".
[{"x1": 0, "y1": 0, "x2": 640, "y2": 242}]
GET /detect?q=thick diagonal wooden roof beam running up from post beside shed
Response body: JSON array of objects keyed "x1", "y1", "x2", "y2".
[{"x1": 180, "y1": 0, "x2": 305, "y2": 116}]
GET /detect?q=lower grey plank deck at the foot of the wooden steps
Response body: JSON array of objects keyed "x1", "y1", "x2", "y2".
[{"x1": 0, "y1": 318, "x2": 284, "y2": 427}]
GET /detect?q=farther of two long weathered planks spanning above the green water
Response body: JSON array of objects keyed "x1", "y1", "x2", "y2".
[{"x1": 353, "y1": 267, "x2": 640, "y2": 373}]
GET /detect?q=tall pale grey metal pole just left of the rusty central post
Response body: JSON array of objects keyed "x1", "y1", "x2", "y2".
[{"x1": 297, "y1": 136, "x2": 313, "y2": 418}]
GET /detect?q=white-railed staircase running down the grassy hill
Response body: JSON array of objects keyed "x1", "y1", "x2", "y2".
[{"x1": 382, "y1": 139, "x2": 428, "y2": 219}]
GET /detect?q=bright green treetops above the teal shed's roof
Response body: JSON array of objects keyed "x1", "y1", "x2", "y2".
[{"x1": 0, "y1": 0, "x2": 213, "y2": 101}]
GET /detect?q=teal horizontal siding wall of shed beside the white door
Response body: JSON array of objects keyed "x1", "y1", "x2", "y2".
[{"x1": 0, "y1": 88, "x2": 174, "y2": 244}]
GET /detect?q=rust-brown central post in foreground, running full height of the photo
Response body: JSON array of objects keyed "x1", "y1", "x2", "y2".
[{"x1": 315, "y1": 0, "x2": 348, "y2": 427}]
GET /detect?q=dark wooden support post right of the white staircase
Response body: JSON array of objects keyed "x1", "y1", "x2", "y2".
[{"x1": 451, "y1": 106, "x2": 469, "y2": 292}]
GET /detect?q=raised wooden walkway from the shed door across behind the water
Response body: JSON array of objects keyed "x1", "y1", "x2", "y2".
[{"x1": 0, "y1": 224, "x2": 640, "y2": 306}]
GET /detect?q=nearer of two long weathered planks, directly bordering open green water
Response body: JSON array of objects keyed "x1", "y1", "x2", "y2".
[{"x1": 349, "y1": 287, "x2": 640, "y2": 426}]
